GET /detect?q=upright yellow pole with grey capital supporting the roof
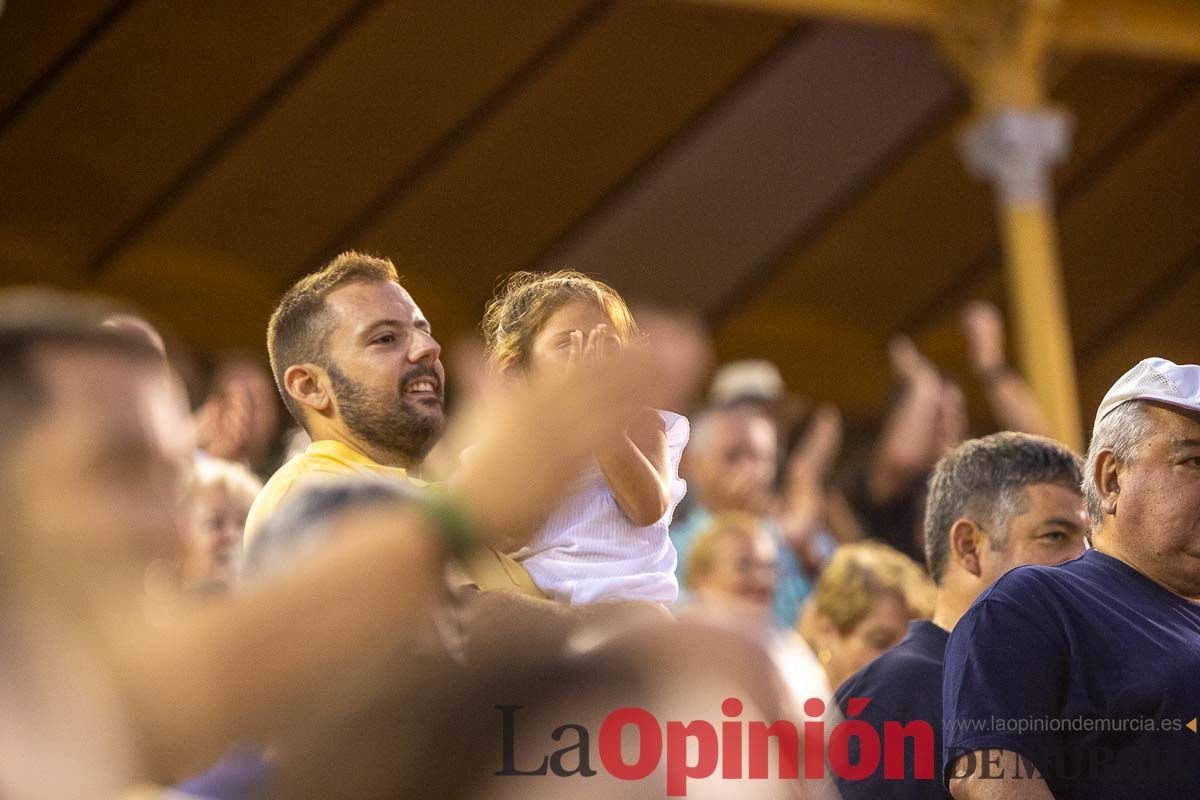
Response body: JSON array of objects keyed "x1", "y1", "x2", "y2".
[{"x1": 942, "y1": 0, "x2": 1084, "y2": 450}]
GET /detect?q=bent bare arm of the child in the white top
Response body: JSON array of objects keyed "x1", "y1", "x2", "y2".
[{"x1": 596, "y1": 409, "x2": 671, "y2": 528}]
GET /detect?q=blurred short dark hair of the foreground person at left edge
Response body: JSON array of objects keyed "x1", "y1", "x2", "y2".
[{"x1": 0, "y1": 288, "x2": 166, "y2": 447}]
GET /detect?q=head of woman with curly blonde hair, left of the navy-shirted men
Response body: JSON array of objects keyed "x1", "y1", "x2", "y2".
[{"x1": 799, "y1": 541, "x2": 935, "y2": 690}]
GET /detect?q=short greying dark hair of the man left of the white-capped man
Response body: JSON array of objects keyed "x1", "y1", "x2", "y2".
[{"x1": 925, "y1": 432, "x2": 1082, "y2": 584}]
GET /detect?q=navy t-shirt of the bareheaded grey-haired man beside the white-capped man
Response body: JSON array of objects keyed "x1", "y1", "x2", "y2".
[{"x1": 834, "y1": 620, "x2": 950, "y2": 800}]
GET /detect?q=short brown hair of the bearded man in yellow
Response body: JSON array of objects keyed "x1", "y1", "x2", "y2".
[{"x1": 266, "y1": 251, "x2": 400, "y2": 429}]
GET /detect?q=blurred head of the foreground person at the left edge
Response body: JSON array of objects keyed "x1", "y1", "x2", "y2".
[{"x1": 0, "y1": 289, "x2": 190, "y2": 597}]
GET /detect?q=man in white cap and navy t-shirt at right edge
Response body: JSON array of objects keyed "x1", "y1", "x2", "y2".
[{"x1": 943, "y1": 359, "x2": 1200, "y2": 800}]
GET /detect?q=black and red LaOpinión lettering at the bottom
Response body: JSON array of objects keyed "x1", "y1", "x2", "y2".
[{"x1": 494, "y1": 697, "x2": 934, "y2": 798}]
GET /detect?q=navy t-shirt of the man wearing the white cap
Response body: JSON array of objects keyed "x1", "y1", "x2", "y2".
[{"x1": 943, "y1": 551, "x2": 1200, "y2": 800}]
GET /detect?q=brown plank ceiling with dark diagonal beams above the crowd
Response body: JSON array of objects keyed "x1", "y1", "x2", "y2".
[{"x1": 0, "y1": 0, "x2": 1200, "y2": 431}]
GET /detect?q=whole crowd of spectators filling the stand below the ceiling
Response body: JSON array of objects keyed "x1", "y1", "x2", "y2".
[{"x1": 0, "y1": 252, "x2": 1200, "y2": 800}]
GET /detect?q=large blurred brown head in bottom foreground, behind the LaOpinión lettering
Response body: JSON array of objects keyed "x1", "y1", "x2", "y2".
[{"x1": 278, "y1": 621, "x2": 816, "y2": 800}]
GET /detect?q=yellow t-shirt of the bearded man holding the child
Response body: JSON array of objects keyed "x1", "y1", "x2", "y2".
[{"x1": 245, "y1": 439, "x2": 545, "y2": 597}]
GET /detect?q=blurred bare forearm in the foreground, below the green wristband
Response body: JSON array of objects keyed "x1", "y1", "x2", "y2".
[{"x1": 99, "y1": 509, "x2": 442, "y2": 781}]
